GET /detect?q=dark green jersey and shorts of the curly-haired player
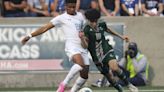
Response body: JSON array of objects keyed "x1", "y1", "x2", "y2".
[{"x1": 84, "y1": 22, "x2": 115, "y2": 63}]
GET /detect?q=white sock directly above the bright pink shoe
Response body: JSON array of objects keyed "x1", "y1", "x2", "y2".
[{"x1": 63, "y1": 64, "x2": 83, "y2": 85}]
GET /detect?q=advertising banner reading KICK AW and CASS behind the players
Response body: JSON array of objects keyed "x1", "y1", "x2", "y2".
[{"x1": 0, "y1": 24, "x2": 124, "y2": 70}]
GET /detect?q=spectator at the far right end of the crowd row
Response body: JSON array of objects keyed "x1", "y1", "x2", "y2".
[{"x1": 141, "y1": 0, "x2": 163, "y2": 16}]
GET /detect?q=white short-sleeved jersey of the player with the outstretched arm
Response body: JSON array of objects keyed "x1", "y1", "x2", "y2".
[{"x1": 50, "y1": 12, "x2": 86, "y2": 52}]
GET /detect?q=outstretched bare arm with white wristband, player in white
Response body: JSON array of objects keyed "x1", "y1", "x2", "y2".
[{"x1": 21, "y1": 22, "x2": 54, "y2": 45}]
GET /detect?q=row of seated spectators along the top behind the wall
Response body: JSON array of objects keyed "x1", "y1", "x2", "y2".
[{"x1": 0, "y1": 0, "x2": 164, "y2": 17}]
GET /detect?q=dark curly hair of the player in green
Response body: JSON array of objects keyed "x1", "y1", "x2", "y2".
[{"x1": 85, "y1": 9, "x2": 101, "y2": 22}]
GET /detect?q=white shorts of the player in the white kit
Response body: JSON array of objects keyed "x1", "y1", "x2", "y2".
[{"x1": 65, "y1": 48, "x2": 90, "y2": 65}]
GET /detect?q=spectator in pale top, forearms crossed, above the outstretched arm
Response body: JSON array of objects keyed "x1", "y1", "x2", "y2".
[{"x1": 28, "y1": 0, "x2": 50, "y2": 17}]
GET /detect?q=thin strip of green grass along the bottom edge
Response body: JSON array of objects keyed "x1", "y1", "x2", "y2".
[{"x1": 0, "y1": 86, "x2": 164, "y2": 92}]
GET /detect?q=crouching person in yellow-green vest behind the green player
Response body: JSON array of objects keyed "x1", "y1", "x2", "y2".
[{"x1": 119, "y1": 42, "x2": 149, "y2": 86}]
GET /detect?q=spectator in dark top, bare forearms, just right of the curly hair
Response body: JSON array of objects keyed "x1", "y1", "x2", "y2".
[{"x1": 98, "y1": 0, "x2": 120, "y2": 16}]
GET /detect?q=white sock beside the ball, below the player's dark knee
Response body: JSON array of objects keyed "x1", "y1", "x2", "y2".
[{"x1": 71, "y1": 77, "x2": 87, "y2": 92}]
